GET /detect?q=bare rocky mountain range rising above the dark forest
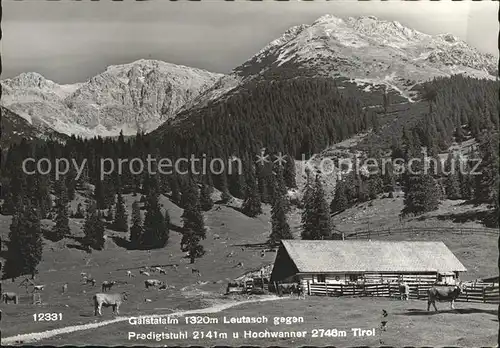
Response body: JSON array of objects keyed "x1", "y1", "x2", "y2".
[{"x1": 1, "y1": 15, "x2": 498, "y2": 143}]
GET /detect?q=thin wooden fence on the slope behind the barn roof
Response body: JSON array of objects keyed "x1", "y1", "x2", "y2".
[{"x1": 344, "y1": 227, "x2": 499, "y2": 239}]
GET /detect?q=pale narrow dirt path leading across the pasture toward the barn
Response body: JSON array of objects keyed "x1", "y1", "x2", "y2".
[{"x1": 2, "y1": 297, "x2": 286, "y2": 345}]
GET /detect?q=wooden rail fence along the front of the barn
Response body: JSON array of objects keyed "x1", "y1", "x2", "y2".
[{"x1": 307, "y1": 282, "x2": 500, "y2": 304}]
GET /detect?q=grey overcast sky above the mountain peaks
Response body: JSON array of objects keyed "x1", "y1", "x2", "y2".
[{"x1": 2, "y1": 0, "x2": 498, "y2": 83}]
